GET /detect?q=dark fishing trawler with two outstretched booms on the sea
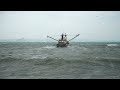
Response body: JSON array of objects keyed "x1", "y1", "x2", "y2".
[{"x1": 47, "y1": 33, "x2": 80, "y2": 47}]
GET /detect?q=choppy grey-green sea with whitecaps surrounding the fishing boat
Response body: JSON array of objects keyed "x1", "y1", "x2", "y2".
[{"x1": 0, "y1": 42, "x2": 120, "y2": 79}]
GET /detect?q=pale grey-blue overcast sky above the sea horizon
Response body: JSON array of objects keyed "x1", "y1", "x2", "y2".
[{"x1": 0, "y1": 11, "x2": 120, "y2": 41}]
